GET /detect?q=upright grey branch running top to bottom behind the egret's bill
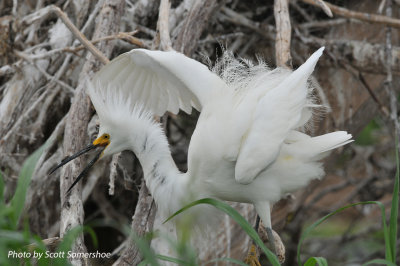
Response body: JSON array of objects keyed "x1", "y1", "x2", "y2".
[{"x1": 60, "y1": 0, "x2": 124, "y2": 265}]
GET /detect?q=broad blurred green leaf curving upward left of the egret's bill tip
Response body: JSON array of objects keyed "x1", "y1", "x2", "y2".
[{"x1": 10, "y1": 141, "x2": 49, "y2": 229}]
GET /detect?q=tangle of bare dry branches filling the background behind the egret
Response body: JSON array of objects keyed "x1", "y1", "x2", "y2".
[{"x1": 0, "y1": 0, "x2": 400, "y2": 265}]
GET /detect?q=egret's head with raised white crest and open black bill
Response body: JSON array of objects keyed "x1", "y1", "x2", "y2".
[{"x1": 50, "y1": 79, "x2": 154, "y2": 192}]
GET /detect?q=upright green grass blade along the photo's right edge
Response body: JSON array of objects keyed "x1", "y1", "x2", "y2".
[{"x1": 386, "y1": 130, "x2": 399, "y2": 263}]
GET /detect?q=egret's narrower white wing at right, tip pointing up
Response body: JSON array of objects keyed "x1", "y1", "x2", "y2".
[{"x1": 235, "y1": 47, "x2": 324, "y2": 184}]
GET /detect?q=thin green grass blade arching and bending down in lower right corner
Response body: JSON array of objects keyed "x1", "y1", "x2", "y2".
[{"x1": 297, "y1": 201, "x2": 392, "y2": 265}]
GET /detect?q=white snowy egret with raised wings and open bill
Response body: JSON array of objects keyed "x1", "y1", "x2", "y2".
[{"x1": 51, "y1": 45, "x2": 351, "y2": 254}]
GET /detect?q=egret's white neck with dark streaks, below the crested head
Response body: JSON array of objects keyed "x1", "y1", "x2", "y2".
[{"x1": 132, "y1": 119, "x2": 186, "y2": 215}]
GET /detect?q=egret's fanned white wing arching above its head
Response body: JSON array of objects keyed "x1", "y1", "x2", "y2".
[{"x1": 90, "y1": 49, "x2": 226, "y2": 115}]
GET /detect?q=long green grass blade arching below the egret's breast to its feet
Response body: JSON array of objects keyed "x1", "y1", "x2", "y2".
[{"x1": 164, "y1": 198, "x2": 280, "y2": 266}]
